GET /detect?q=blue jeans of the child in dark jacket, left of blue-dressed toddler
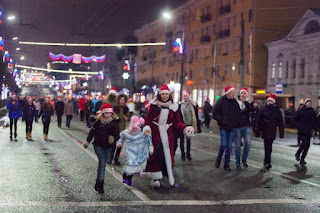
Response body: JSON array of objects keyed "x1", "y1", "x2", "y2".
[{"x1": 94, "y1": 146, "x2": 112, "y2": 183}]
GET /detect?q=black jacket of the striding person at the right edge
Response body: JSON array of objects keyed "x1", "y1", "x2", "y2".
[{"x1": 296, "y1": 106, "x2": 319, "y2": 137}]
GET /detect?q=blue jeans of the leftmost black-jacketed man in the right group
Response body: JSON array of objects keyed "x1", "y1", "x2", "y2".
[{"x1": 217, "y1": 129, "x2": 236, "y2": 165}]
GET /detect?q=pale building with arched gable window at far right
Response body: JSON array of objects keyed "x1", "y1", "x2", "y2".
[{"x1": 267, "y1": 9, "x2": 320, "y2": 107}]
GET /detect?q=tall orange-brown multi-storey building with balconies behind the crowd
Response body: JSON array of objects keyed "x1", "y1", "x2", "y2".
[{"x1": 135, "y1": 0, "x2": 320, "y2": 106}]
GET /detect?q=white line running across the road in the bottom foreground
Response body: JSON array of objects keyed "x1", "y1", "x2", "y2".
[{"x1": 0, "y1": 199, "x2": 320, "y2": 207}]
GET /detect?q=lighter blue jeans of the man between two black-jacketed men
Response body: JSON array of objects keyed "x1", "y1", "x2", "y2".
[{"x1": 235, "y1": 126, "x2": 251, "y2": 165}]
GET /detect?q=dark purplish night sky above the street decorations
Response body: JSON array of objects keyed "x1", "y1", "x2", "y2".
[{"x1": 0, "y1": 0, "x2": 188, "y2": 67}]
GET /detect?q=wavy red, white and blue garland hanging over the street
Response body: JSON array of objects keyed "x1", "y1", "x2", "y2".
[{"x1": 49, "y1": 52, "x2": 106, "y2": 64}]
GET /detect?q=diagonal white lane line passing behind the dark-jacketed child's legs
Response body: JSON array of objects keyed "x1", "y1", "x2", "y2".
[{"x1": 55, "y1": 125, "x2": 150, "y2": 201}]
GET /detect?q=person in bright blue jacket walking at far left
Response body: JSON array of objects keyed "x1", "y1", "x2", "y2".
[{"x1": 7, "y1": 95, "x2": 21, "y2": 141}]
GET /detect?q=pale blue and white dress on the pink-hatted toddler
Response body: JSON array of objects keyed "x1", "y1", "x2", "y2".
[{"x1": 117, "y1": 129, "x2": 153, "y2": 175}]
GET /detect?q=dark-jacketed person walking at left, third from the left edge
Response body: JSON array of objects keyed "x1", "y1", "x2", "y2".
[{"x1": 39, "y1": 98, "x2": 54, "y2": 140}]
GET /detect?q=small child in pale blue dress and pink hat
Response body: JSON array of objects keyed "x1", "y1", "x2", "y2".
[{"x1": 117, "y1": 115, "x2": 154, "y2": 186}]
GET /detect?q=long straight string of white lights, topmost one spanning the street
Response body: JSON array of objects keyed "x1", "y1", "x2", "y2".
[{"x1": 19, "y1": 41, "x2": 166, "y2": 47}]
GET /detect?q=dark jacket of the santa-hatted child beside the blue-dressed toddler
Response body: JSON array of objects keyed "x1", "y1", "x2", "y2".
[{"x1": 87, "y1": 120, "x2": 119, "y2": 148}]
